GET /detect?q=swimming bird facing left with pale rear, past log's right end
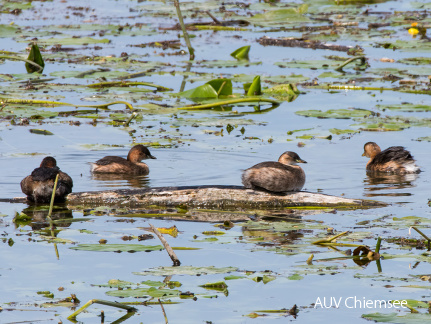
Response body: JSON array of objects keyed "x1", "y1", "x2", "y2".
[{"x1": 362, "y1": 142, "x2": 421, "y2": 174}]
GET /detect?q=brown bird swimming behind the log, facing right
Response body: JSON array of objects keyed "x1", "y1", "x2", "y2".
[{"x1": 91, "y1": 145, "x2": 156, "y2": 175}]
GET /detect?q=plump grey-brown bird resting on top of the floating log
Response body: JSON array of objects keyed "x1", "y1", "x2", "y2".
[{"x1": 242, "y1": 151, "x2": 307, "y2": 192}]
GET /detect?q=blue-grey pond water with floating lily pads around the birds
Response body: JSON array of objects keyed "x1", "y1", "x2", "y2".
[{"x1": 0, "y1": 0, "x2": 431, "y2": 323}]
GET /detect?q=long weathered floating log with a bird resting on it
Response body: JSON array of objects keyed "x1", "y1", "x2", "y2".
[{"x1": 67, "y1": 186, "x2": 387, "y2": 210}]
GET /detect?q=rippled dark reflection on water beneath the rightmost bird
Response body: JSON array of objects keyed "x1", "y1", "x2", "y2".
[{"x1": 364, "y1": 173, "x2": 419, "y2": 197}]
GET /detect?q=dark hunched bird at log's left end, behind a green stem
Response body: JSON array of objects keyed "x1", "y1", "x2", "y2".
[{"x1": 21, "y1": 156, "x2": 73, "y2": 204}]
